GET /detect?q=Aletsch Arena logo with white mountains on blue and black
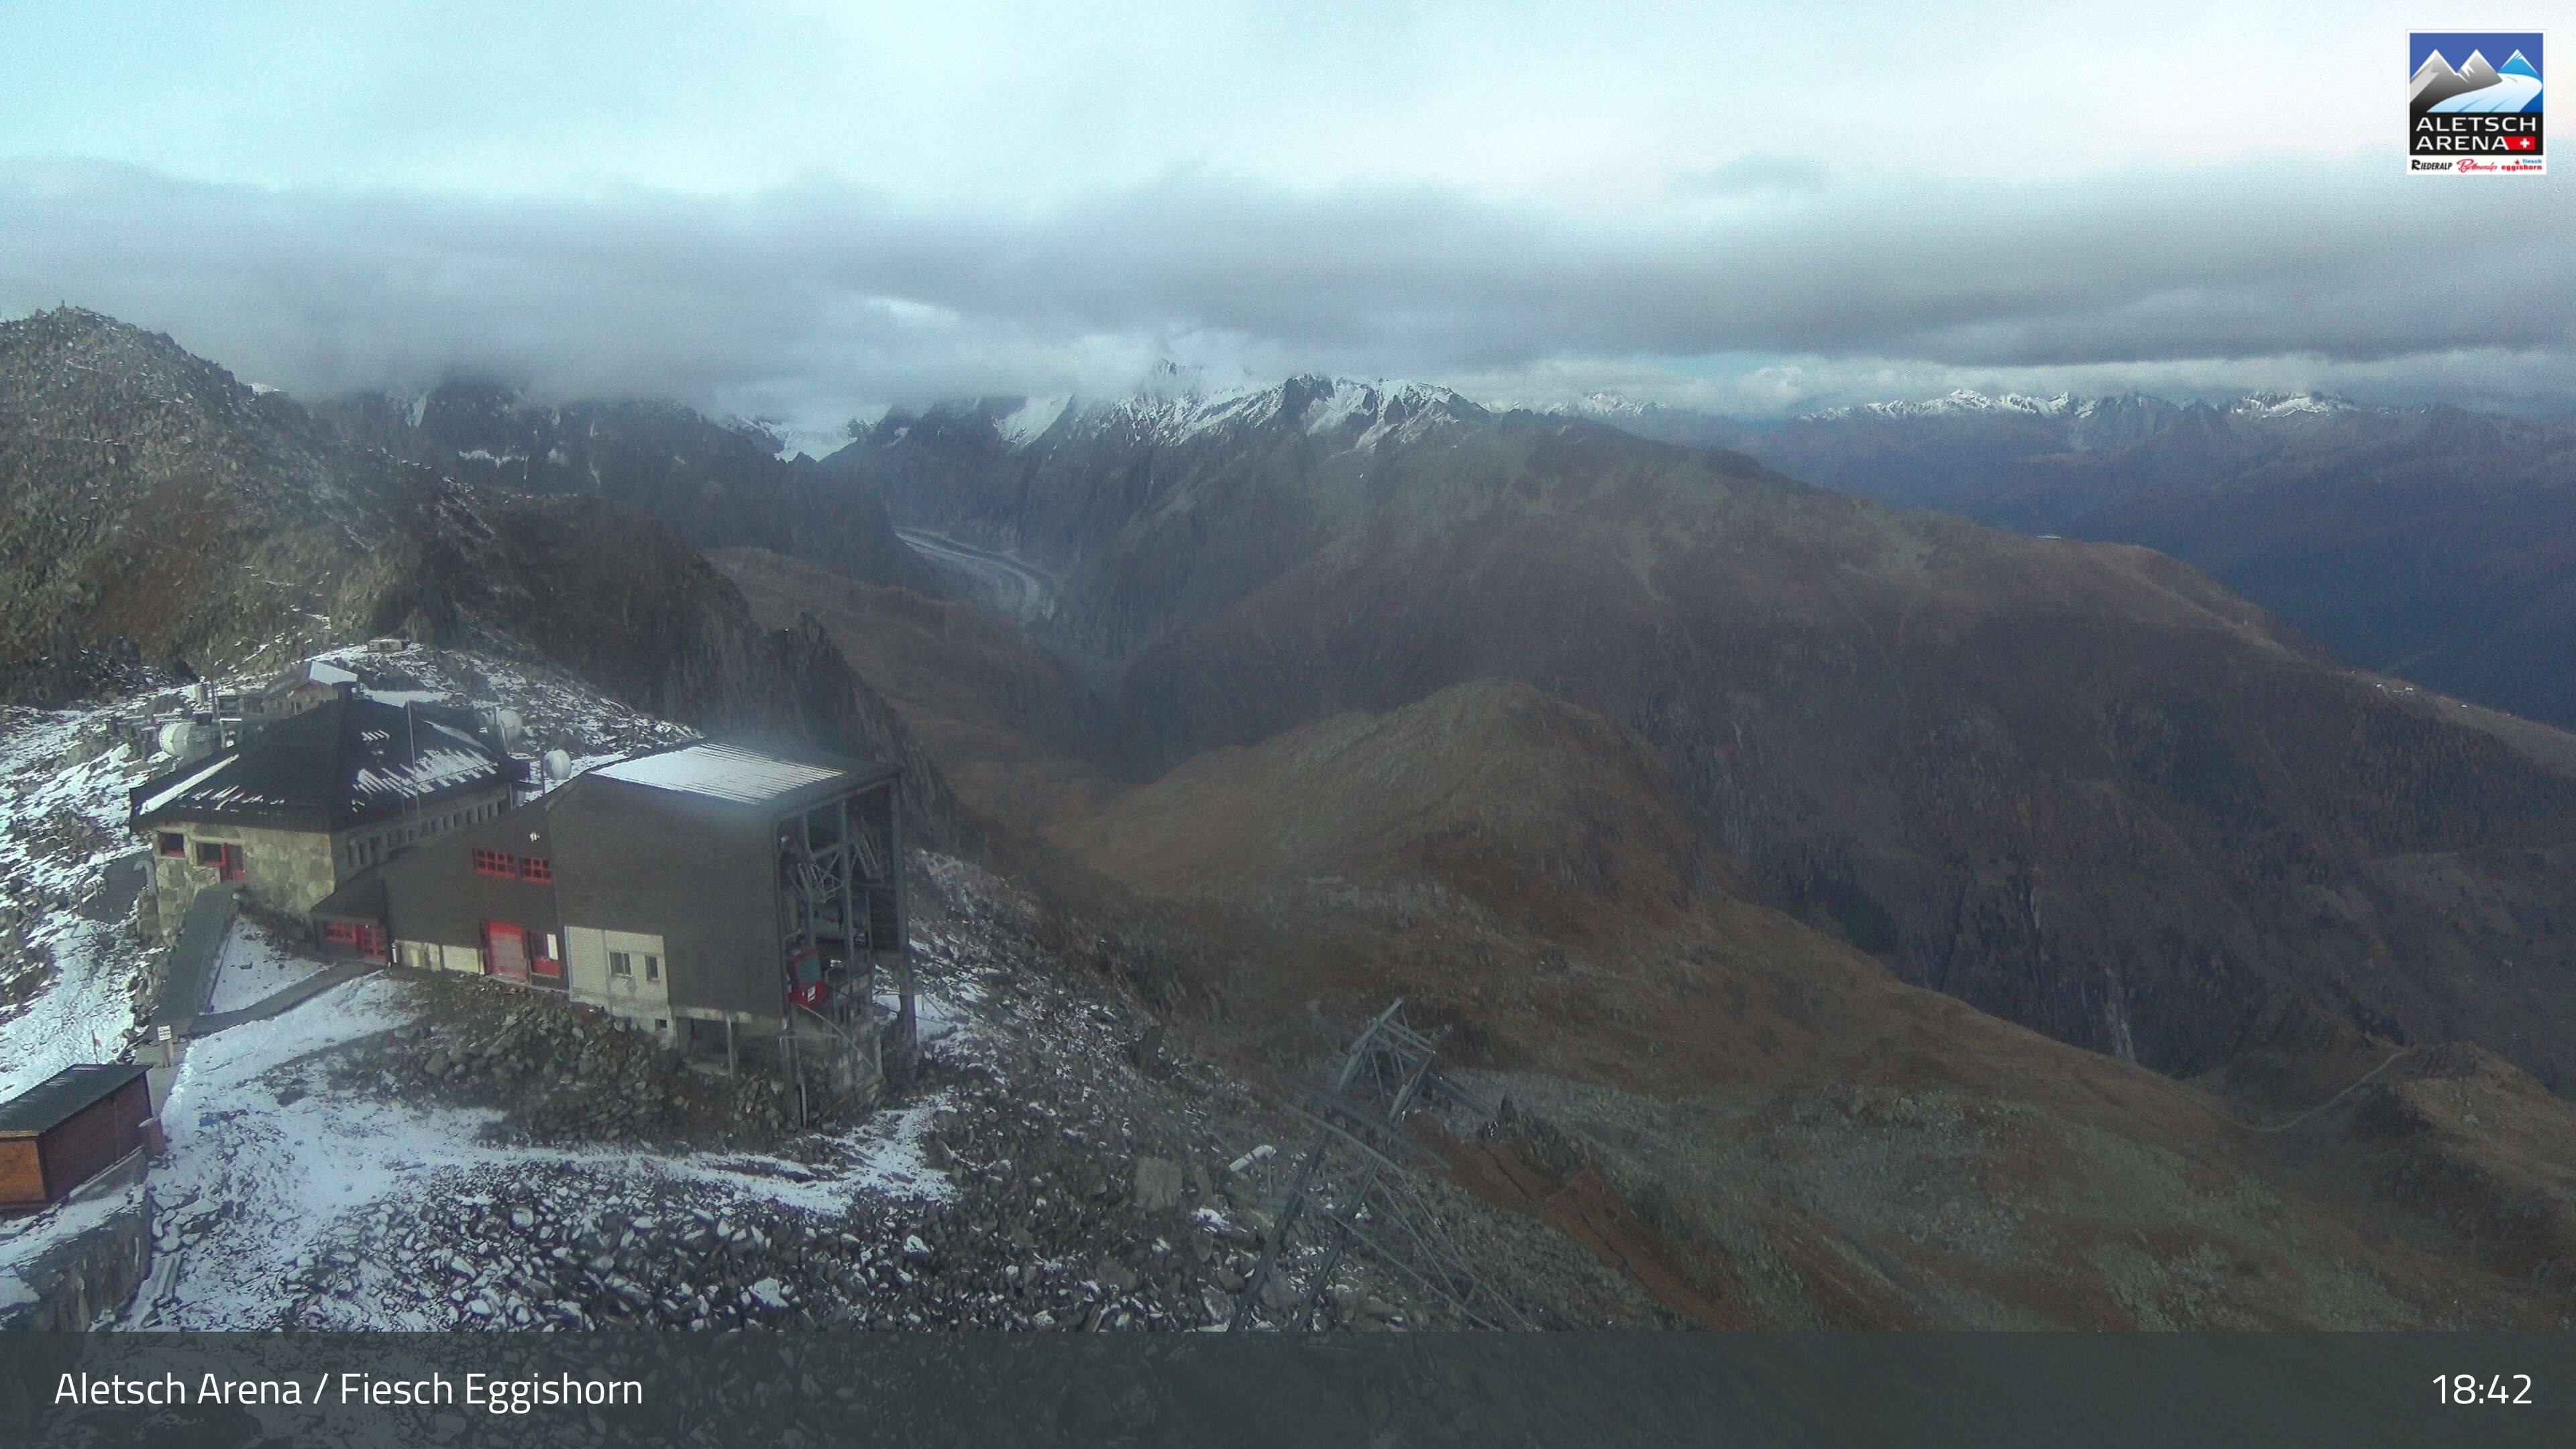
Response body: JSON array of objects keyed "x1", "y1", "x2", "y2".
[{"x1": 2406, "y1": 31, "x2": 2548, "y2": 175}]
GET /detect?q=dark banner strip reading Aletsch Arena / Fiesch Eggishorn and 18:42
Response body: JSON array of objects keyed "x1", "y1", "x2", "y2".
[{"x1": 0, "y1": 1333, "x2": 2576, "y2": 1449}]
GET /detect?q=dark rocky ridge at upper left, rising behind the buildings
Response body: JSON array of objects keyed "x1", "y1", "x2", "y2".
[{"x1": 0, "y1": 309, "x2": 956, "y2": 841}]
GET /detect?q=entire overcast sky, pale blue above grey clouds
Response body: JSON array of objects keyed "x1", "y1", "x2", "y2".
[{"x1": 0, "y1": 0, "x2": 2576, "y2": 423}]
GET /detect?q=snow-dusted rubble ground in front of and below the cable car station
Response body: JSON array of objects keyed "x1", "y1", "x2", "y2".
[{"x1": 115, "y1": 859, "x2": 1654, "y2": 1330}]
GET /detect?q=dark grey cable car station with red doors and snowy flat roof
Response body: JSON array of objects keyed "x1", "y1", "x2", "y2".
[{"x1": 318, "y1": 724, "x2": 912, "y2": 1095}]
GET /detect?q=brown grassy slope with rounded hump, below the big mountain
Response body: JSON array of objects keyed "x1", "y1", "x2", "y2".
[{"x1": 1051, "y1": 681, "x2": 2576, "y2": 1328}]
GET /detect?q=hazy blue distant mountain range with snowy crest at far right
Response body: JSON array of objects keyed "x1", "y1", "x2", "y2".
[{"x1": 1504, "y1": 392, "x2": 2576, "y2": 724}]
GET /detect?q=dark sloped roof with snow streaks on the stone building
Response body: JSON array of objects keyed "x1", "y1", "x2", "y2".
[{"x1": 129, "y1": 696, "x2": 521, "y2": 830}]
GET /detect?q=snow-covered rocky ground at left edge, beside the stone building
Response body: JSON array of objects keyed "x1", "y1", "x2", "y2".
[{"x1": 0, "y1": 709, "x2": 150, "y2": 1098}]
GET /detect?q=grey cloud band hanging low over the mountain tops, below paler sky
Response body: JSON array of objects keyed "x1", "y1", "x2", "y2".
[{"x1": 0, "y1": 157, "x2": 2576, "y2": 418}]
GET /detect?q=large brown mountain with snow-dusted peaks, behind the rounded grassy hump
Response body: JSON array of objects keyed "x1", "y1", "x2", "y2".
[{"x1": 827, "y1": 379, "x2": 2576, "y2": 1085}]
